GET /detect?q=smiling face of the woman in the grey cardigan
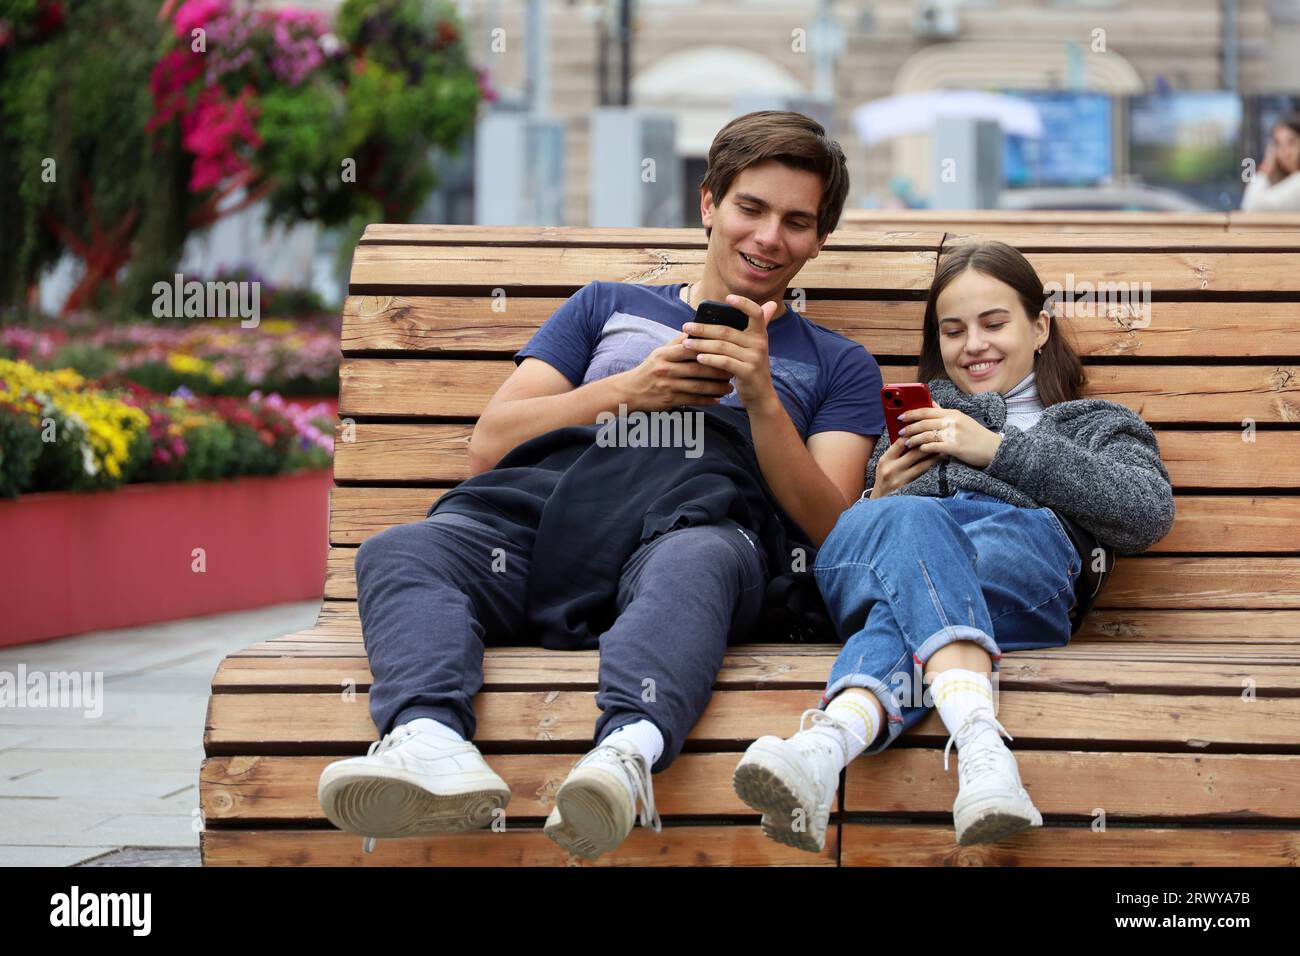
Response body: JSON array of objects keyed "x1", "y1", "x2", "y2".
[{"x1": 935, "y1": 268, "x2": 1050, "y2": 395}]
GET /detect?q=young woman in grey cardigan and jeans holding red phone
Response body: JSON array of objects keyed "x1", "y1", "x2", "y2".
[{"x1": 735, "y1": 242, "x2": 1174, "y2": 851}]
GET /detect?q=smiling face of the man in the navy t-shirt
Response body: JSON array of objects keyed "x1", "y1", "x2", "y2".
[{"x1": 699, "y1": 160, "x2": 828, "y2": 304}]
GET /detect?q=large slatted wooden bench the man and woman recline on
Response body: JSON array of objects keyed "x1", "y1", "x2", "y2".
[{"x1": 200, "y1": 221, "x2": 1300, "y2": 866}]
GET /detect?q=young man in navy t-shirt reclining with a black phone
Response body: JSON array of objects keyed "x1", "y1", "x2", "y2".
[{"x1": 319, "y1": 111, "x2": 884, "y2": 858}]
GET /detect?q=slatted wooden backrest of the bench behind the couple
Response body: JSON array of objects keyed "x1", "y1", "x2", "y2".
[{"x1": 321, "y1": 223, "x2": 1300, "y2": 640}]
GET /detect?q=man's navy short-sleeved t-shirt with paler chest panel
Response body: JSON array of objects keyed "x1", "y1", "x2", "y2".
[{"x1": 515, "y1": 281, "x2": 885, "y2": 442}]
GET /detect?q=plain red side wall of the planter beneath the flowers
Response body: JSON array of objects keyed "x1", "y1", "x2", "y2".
[{"x1": 0, "y1": 468, "x2": 333, "y2": 646}]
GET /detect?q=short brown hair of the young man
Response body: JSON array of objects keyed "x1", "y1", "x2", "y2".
[{"x1": 699, "y1": 109, "x2": 849, "y2": 238}]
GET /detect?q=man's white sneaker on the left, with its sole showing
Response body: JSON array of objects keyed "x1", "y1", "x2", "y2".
[{"x1": 316, "y1": 723, "x2": 511, "y2": 852}]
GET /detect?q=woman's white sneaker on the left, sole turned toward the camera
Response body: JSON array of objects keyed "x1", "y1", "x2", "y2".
[{"x1": 732, "y1": 708, "x2": 866, "y2": 853}]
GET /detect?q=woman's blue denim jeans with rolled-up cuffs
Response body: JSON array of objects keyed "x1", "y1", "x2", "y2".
[{"x1": 814, "y1": 490, "x2": 1080, "y2": 754}]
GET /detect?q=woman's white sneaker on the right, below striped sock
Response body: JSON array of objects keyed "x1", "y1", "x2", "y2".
[{"x1": 944, "y1": 713, "x2": 1043, "y2": 845}]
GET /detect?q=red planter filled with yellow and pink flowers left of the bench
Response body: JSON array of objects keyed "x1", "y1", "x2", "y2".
[{"x1": 0, "y1": 359, "x2": 334, "y2": 645}]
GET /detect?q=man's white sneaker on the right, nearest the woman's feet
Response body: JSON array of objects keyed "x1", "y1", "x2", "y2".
[{"x1": 543, "y1": 735, "x2": 663, "y2": 860}]
